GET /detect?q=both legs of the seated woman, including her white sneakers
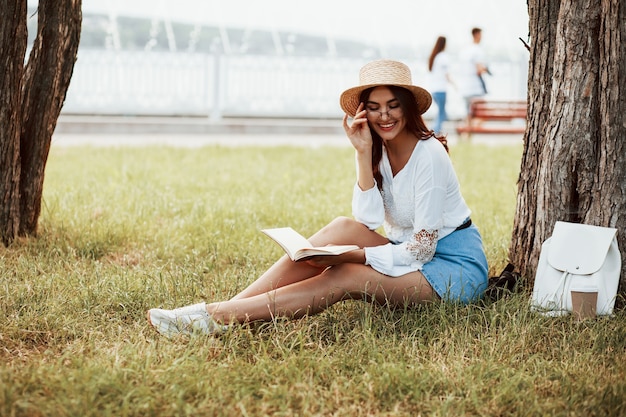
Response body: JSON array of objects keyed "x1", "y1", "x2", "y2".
[{"x1": 148, "y1": 218, "x2": 439, "y2": 337}]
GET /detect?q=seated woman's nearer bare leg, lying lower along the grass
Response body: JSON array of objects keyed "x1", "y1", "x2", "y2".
[{"x1": 206, "y1": 264, "x2": 438, "y2": 323}]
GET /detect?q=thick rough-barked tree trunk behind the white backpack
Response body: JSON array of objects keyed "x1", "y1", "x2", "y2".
[{"x1": 509, "y1": 0, "x2": 626, "y2": 292}]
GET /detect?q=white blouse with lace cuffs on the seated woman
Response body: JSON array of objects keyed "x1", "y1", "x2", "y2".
[{"x1": 352, "y1": 138, "x2": 471, "y2": 276}]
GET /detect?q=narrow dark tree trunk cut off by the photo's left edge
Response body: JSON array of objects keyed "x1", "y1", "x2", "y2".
[{"x1": 0, "y1": 0, "x2": 27, "y2": 242}]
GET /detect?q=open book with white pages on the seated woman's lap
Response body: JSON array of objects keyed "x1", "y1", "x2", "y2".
[{"x1": 261, "y1": 227, "x2": 359, "y2": 261}]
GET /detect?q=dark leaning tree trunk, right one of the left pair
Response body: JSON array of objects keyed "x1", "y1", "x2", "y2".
[{"x1": 19, "y1": 0, "x2": 82, "y2": 236}]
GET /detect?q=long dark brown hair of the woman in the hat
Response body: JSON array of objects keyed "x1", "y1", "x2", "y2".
[{"x1": 359, "y1": 85, "x2": 448, "y2": 189}]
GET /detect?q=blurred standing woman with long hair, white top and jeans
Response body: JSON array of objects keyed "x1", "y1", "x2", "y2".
[{"x1": 428, "y1": 36, "x2": 454, "y2": 135}]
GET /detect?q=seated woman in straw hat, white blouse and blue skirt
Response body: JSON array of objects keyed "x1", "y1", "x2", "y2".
[{"x1": 148, "y1": 60, "x2": 488, "y2": 337}]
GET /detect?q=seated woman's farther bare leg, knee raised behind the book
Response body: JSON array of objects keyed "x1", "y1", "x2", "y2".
[{"x1": 231, "y1": 217, "x2": 388, "y2": 301}]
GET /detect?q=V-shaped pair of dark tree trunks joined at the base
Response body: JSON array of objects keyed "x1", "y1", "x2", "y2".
[{"x1": 0, "y1": 0, "x2": 82, "y2": 245}]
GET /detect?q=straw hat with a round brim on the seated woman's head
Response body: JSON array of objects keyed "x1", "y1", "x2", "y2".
[{"x1": 339, "y1": 59, "x2": 433, "y2": 116}]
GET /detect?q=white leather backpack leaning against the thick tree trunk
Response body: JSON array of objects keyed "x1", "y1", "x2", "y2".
[{"x1": 531, "y1": 221, "x2": 622, "y2": 316}]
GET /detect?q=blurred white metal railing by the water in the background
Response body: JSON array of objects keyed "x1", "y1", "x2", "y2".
[{"x1": 63, "y1": 50, "x2": 527, "y2": 119}]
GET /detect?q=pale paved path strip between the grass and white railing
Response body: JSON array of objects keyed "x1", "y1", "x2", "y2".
[{"x1": 52, "y1": 116, "x2": 523, "y2": 148}]
